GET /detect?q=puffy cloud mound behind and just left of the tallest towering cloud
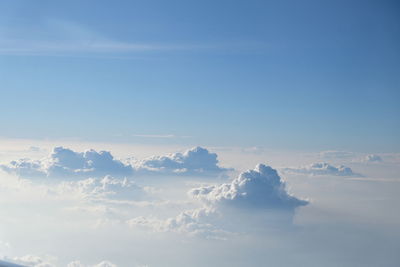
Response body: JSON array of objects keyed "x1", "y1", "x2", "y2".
[{"x1": 136, "y1": 147, "x2": 228, "y2": 175}]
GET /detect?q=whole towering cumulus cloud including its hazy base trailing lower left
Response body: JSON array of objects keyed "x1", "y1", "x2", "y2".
[{"x1": 127, "y1": 164, "x2": 308, "y2": 239}]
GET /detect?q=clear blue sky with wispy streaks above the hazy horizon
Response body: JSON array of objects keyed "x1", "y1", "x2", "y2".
[{"x1": 0, "y1": 0, "x2": 400, "y2": 152}]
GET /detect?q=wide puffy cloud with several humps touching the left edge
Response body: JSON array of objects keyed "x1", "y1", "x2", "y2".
[{"x1": 0, "y1": 147, "x2": 133, "y2": 178}]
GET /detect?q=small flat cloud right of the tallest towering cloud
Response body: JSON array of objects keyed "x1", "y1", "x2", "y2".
[{"x1": 283, "y1": 162, "x2": 360, "y2": 176}]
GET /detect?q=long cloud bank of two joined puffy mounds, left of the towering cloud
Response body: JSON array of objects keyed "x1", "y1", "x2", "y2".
[{"x1": 0, "y1": 147, "x2": 228, "y2": 178}]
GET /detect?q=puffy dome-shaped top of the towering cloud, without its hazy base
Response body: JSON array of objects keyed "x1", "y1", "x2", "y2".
[{"x1": 189, "y1": 164, "x2": 308, "y2": 209}]
